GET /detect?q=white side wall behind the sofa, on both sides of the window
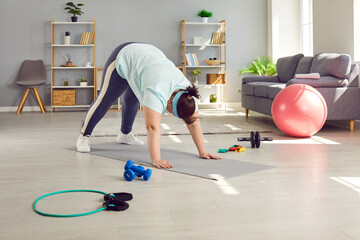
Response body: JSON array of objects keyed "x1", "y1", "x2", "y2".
[{"x1": 268, "y1": 0, "x2": 360, "y2": 61}]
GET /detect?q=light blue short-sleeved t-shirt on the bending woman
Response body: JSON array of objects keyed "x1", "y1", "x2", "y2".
[{"x1": 116, "y1": 43, "x2": 191, "y2": 113}]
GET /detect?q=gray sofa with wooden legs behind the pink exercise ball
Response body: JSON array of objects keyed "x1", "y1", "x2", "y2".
[{"x1": 241, "y1": 53, "x2": 360, "y2": 131}]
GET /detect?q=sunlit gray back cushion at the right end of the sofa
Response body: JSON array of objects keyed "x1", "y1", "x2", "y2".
[{"x1": 310, "y1": 53, "x2": 351, "y2": 79}]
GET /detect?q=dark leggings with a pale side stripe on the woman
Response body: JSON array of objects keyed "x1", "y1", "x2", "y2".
[{"x1": 80, "y1": 42, "x2": 140, "y2": 136}]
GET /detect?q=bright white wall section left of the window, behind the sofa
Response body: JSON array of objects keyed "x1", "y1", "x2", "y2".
[{"x1": 268, "y1": 0, "x2": 301, "y2": 61}]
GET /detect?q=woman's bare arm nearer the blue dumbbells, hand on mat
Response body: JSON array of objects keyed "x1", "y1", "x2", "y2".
[{"x1": 144, "y1": 106, "x2": 172, "y2": 168}]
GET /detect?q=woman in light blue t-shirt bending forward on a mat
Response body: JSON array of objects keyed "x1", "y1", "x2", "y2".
[{"x1": 76, "y1": 43, "x2": 220, "y2": 168}]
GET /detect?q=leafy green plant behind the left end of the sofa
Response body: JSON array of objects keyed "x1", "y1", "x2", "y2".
[{"x1": 239, "y1": 57, "x2": 276, "y2": 76}]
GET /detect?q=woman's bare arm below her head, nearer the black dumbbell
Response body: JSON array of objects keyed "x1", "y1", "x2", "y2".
[{"x1": 185, "y1": 113, "x2": 221, "y2": 159}]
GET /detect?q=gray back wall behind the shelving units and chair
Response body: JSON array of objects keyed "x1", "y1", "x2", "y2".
[{"x1": 0, "y1": 0, "x2": 267, "y2": 107}]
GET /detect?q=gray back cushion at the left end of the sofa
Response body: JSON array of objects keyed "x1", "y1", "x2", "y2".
[{"x1": 276, "y1": 54, "x2": 304, "y2": 83}]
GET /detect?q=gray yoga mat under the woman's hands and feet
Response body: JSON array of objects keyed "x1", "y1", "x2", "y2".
[{"x1": 85, "y1": 142, "x2": 274, "y2": 180}]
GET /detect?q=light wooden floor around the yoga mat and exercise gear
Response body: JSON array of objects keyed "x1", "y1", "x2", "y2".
[{"x1": 0, "y1": 108, "x2": 360, "y2": 240}]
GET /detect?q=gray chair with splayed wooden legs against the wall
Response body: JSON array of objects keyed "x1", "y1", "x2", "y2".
[{"x1": 16, "y1": 60, "x2": 46, "y2": 114}]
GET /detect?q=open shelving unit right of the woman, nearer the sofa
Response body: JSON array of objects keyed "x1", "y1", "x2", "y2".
[{"x1": 180, "y1": 19, "x2": 227, "y2": 108}]
